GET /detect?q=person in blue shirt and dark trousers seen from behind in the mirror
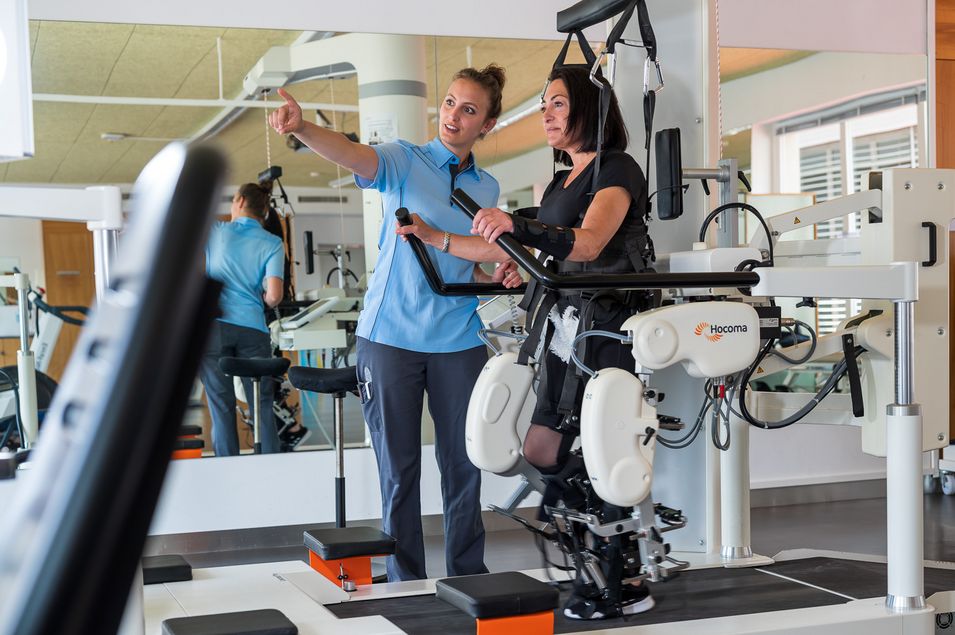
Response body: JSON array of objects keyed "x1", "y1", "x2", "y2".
[{"x1": 199, "y1": 183, "x2": 285, "y2": 456}]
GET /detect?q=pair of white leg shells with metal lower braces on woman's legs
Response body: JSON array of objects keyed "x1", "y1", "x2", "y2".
[{"x1": 465, "y1": 342, "x2": 686, "y2": 593}]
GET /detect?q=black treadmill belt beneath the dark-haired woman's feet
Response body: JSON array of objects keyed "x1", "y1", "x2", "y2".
[{"x1": 325, "y1": 558, "x2": 955, "y2": 635}]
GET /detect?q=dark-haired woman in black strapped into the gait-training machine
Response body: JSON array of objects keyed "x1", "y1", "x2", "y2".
[{"x1": 396, "y1": 67, "x2": 654, "y2": 619}]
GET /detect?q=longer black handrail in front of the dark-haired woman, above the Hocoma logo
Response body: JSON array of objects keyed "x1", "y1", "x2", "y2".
[{"x1": 451, "y1": 189, "x2": 759, "y2": 290}]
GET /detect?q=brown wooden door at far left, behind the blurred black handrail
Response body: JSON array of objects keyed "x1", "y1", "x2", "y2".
[{"x1": 43, "y1": 221, "x2": 96, "y2": 382}]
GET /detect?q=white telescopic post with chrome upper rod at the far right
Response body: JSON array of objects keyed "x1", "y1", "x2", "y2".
[{"x1": 885, "y1": 301, "x2": 925, "y2": 612}]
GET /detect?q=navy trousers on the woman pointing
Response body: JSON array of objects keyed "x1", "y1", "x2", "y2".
[{"x1": 357, "y1": 338, "x2": 487, "y2": 582}]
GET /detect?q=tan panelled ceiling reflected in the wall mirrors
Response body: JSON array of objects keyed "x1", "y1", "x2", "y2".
[{"x1": 11, "y1": 21, "x2": 805, "y2": 186}]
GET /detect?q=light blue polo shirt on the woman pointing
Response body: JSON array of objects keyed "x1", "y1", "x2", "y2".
[{"x1": 355, "y1": 138, "x2": 500, "y2": 353}]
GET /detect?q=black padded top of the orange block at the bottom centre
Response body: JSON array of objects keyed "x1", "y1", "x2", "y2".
[{"x1": 435, "y1": 571, "x2": 560, "y2": 619}]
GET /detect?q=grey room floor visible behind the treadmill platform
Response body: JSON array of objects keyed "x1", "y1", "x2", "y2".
[{"x1": 188, "y1": 494, "x2": 955, "y2": 577}]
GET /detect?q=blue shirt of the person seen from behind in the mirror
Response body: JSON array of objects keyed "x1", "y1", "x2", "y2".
[{"x1": 206, "y1": 217, "x2": 285, "y2": 333}]
